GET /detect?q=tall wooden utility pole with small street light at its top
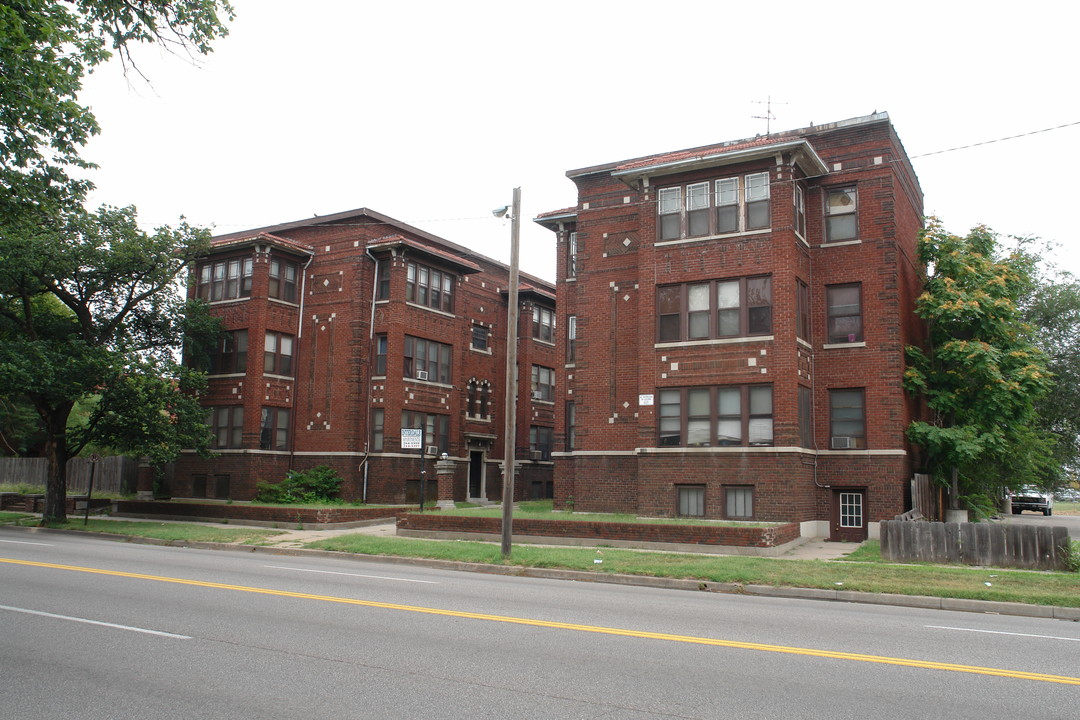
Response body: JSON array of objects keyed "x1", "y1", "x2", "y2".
[{"x1": 491, "y1": 188, "x2": 522, "y2": 558}]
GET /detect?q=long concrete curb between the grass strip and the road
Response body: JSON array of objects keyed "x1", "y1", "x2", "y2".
[{"x1": 10, "y1": 526, "x2": 1080, "y2": 622}]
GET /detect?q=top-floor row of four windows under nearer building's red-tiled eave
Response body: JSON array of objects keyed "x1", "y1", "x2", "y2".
[{"x1": 657, "y1": 172, "x2": 772, "y2": 241}]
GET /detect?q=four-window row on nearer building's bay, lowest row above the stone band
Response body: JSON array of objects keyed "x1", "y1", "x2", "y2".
[{"x1": 659, "y1": 385, "x2": 773, "y2": 447}]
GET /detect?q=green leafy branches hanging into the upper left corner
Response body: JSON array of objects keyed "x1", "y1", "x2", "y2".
[{"x1": 0, "y1": 0, "x2": 233, "y2": 218}]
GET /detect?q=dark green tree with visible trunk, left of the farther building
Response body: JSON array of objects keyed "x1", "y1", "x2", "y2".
[{"x1": 0, "y1": 207, "x2": 219, "y2": 521}]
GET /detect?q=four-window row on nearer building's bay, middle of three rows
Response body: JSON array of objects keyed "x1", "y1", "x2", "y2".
[{"x1": 657, "y1": 275, "x2": 772, "y2": 342}]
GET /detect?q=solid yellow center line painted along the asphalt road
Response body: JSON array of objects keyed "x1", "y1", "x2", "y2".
[{"x1": 0, "y1": 558, "x2": 1080, "y2": 685}]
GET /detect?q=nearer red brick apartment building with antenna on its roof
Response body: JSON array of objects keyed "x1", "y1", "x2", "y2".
[{"x1": 536, "y1": 112, "x2": 923, "y2": 540}]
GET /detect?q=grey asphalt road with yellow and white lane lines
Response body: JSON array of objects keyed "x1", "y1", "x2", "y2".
[{"x1": 0, "y1": 528, "x2": 1080, "y2": 720}]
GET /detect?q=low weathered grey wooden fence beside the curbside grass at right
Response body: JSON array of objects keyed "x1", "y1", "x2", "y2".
[{"x1": 881, "y1": 520, "x2": 1070, "y2": 570}]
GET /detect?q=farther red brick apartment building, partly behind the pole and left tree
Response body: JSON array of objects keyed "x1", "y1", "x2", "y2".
[{"x1": 172, "y1": 208, "x2": 561, "y2": 503}]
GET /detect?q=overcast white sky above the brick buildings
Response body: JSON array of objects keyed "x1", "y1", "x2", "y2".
[{"x1": 82, "y1": 0, "x2": 1080, "y2": 280}]
